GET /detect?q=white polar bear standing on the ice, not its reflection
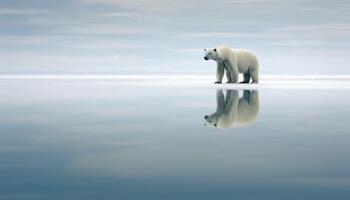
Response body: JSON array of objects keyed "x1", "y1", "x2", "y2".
[{"x1": 204, "y1": 46, "x2": 259, "y2": 83}]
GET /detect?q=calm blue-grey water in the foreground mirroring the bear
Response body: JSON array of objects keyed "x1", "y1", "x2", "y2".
[{"x1": 0, "y1": 77, "x2": 350, "y2": 200}]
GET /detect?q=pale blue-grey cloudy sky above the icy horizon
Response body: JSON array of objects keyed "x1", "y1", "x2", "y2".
[{"x1": 0, "y1": 0, "x2": 350, "y2": 75}]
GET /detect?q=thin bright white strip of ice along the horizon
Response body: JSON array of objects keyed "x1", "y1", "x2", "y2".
[{"x1": 0, "y1": 75, "x2": 350, "y2": 90}]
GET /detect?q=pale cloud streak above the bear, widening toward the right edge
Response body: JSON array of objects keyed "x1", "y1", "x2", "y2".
[{"x1": 173, "y1": 23, "x2": 350, "y2": 47}]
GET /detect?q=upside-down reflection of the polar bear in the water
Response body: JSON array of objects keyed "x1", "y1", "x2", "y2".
[{"x1": 204, "y1": 89, "x2": 259, "y2": 128}]
